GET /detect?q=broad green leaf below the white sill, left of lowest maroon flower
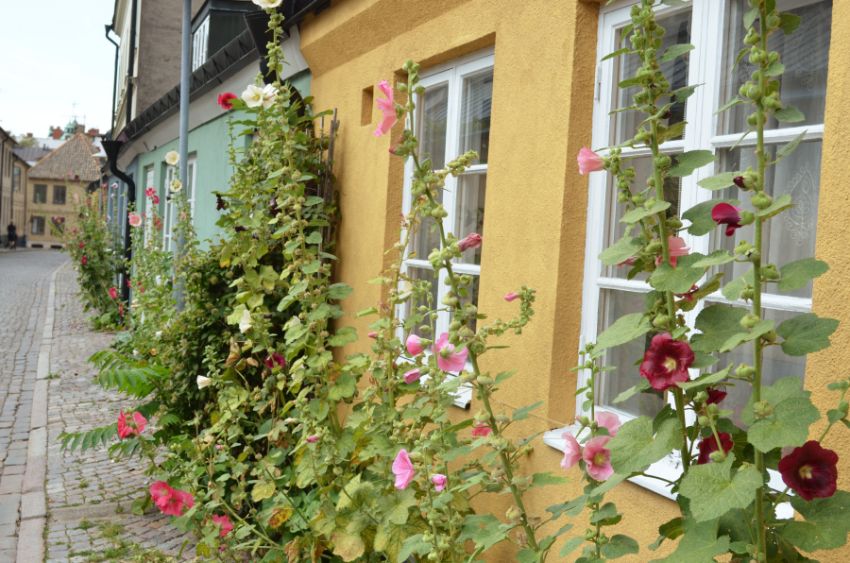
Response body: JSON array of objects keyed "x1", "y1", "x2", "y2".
[{"x1": 676, "y1": 456, "x2": 762, "y2": 524}]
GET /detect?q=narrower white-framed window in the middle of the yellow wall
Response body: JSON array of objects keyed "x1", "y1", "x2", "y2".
[{"x1": 401, "y1": 54, "x2": 493, "y2": 342}]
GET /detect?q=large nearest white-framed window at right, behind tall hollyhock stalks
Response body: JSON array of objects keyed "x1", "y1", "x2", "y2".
[{"x1": 578, "y1": 0, "x2": 832, "y2": 428}]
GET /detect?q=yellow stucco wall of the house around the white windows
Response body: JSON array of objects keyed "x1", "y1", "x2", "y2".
[{"x1": 301, "y1": 0, "x2": 850, "y2": 561}]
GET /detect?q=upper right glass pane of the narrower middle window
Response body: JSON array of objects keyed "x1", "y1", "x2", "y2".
[{"x1": 460, "y1": 69, "x2": 493, "y2": 164}]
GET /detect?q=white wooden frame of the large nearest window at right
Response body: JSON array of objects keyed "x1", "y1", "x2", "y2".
[{"x1": 544, "y1": 0, "x2": 824, "y2": 502}]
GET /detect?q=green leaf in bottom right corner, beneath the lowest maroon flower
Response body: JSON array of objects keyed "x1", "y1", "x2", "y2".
[{"x1": 780, "y1": 491, "x2": 850, "y2": 551}]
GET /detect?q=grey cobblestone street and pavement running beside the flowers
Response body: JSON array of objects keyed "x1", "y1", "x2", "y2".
[{"x1": 0, "y1": 250, "x2": 194, "y2": 563}]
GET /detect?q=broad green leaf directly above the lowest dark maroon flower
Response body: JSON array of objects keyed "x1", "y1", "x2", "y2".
[{"x1": 741, "y1": 375, "x2": 820, "y2": 453}]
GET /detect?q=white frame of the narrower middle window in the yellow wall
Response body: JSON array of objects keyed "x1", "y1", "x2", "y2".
[{"x1": 396, "y1": 48, "x2": 495, "y2": 409}]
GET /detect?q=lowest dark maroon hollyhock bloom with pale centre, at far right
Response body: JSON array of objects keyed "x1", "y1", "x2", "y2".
[{"x1": 779, "y1": 440, "x2": 838, "y2": 500}]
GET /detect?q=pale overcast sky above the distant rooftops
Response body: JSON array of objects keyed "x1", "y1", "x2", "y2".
[{"x1": 0, "y1": 0, "x2": 115, "y2": 137}]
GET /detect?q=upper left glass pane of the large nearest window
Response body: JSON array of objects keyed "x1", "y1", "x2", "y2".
[{"x1": 611, "y1": 10, "x2": 691, "y2": 144}]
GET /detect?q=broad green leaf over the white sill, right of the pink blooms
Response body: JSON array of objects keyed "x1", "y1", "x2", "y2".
[{"x1": 608, "y1": 416, "x2": 682, "y2": 474}]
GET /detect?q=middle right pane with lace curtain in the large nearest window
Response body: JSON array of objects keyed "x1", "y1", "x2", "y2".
[{"x1": 711, "y1": 141, "x2": 821, "y2": 297}]
